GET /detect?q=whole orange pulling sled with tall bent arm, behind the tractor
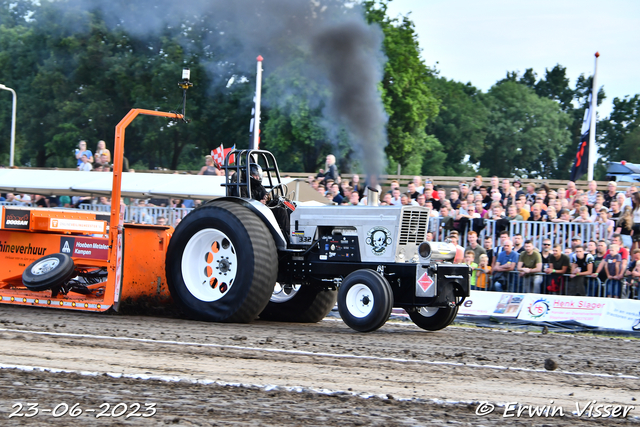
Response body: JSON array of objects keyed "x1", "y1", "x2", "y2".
[{"x1": 0, "y1": 109, "x2": 184, "y2": 311}]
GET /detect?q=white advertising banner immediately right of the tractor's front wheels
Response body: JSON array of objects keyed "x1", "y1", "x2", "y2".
[{"x1": 458, "y1": 291, "x2": 525, "y2": 318}]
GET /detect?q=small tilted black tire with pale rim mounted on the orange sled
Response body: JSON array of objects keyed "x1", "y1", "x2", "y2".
[{"x1": 22, "y1": 253, "x2": 75, "y2": 291}]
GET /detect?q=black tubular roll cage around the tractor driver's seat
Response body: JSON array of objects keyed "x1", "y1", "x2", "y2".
[{"x1": 222, "y1": 149, "x2": 282, "y2": 198}]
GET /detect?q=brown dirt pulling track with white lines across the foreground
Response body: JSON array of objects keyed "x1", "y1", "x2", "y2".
[{"x1": 0, "y1": 305, "x2": 640, "y2": 426}]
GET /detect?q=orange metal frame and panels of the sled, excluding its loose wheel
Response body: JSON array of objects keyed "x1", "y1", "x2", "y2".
[{"x1": 0, "y1": 108, "x2": 184, "y2": 311}]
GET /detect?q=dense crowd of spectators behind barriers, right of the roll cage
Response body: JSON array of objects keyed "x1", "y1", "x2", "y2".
[{"x1": 308, "y1": 158, "x2": 640, "y2": 299}]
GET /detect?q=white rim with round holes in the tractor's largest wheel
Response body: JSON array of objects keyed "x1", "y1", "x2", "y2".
[{"x1": 182, "y1": 228, "x2": 238, "y2": 302}]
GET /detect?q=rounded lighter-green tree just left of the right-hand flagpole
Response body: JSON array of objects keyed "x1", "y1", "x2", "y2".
[{"x1": 480, "y1": 81, "x2": 571, "y2": 178}]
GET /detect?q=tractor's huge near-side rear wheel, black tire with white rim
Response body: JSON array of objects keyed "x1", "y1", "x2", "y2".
[{"x1": 166, "y1": 201, "x2": 278, "y2": 323}]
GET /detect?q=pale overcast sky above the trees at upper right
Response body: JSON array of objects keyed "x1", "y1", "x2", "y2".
[{"x1": 388, "y1": 0, "x2": 640, "y2": 117}]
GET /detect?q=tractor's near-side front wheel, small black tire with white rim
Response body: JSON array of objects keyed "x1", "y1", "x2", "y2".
[{"x1": 338, "y1": 269, "x2": 393, "y2": 332}]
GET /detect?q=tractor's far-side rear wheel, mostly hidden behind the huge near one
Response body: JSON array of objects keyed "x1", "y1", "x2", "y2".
[{"x1": 260, "y1": 284, "x2": 338, "y2": 323}]
